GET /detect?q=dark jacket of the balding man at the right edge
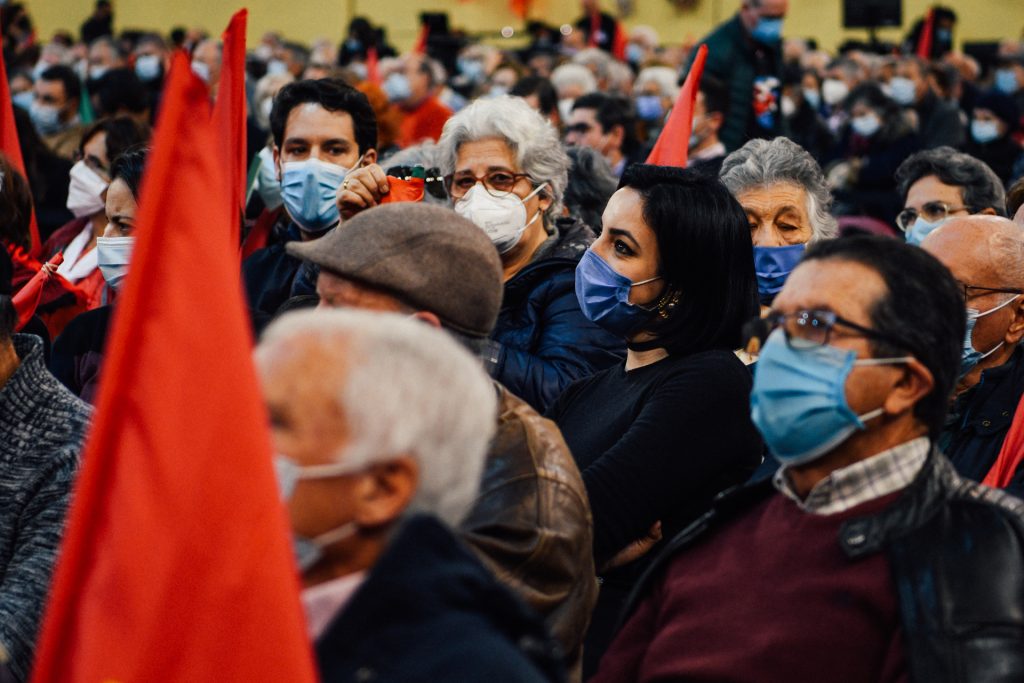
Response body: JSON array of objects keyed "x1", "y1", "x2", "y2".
[{"x1": 938, "y1": 347, "x2": 1024, "y2": 498}]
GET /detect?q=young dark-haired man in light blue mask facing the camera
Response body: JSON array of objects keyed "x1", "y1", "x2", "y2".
[{"x1": 242, "y1": 79, "x2": 377, "y2": 329}]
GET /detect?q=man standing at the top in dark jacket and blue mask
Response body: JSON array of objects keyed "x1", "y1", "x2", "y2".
[{"x1": 683, "y1": 0, "x2": 790, "y2": 152}]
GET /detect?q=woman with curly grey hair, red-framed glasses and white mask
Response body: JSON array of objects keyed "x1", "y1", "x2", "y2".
[{"x1": 438, "y1": 97, "x2": 625, "y2": 411}]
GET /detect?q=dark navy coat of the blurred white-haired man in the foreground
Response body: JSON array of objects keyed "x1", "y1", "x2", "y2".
[{"x1": 315, "y1": 515, "x2": 564, "y2": 683}]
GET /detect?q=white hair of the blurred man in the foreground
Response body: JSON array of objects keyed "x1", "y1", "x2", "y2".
[{"x1": 255, "y1": 308, "x2": 498, "y2": 525}]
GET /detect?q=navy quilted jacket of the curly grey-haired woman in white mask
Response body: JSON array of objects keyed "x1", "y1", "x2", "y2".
[{"x1": 487, "y1": 218, "x2": 626, "y2": 413}]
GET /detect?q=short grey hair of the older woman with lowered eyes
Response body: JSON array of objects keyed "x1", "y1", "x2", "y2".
[{"x1": 719, "y1": 137, "x2": 839, "y2": 242}]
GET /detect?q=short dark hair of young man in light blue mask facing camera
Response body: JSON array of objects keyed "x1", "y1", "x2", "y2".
[{"x1": 270, "y1": 78, "x2": 377, "y2": 155}]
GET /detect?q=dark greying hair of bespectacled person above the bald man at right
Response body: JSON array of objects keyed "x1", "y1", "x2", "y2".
[{"x1": 896, "y1": 146, "x2": 1007, "y2": 216}]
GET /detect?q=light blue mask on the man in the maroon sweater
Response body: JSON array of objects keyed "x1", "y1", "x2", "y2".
[{"x1": 751, "y1": 330, "x2": 910, "y2": 465}]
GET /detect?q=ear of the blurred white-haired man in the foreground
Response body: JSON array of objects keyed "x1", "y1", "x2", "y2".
[{"x1": 355, "y1": 456, "x2": 420, "y2": 528}]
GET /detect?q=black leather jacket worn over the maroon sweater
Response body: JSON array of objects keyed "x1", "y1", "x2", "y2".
[{"x1": 627, "y1": 449, "x2": 1024, "y2": 683}]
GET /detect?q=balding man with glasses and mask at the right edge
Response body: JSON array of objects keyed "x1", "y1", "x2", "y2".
[{"x1": 922, "y1": 216, "x2": 1024, "y2": 497}]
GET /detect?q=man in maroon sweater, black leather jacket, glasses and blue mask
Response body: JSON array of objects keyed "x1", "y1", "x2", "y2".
[{"x1": 591, "y1": 237, "x2": 1024, "y2": 683}]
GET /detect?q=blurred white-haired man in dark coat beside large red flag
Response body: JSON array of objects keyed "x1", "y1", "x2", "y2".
[{"x1": 256, "y1": 310, "x2": 561, "y2": 683}]
